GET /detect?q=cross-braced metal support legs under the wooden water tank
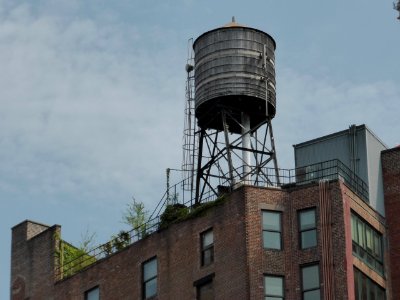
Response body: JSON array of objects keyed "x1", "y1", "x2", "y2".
[{"x1": 195, "y1": 108, "x2": 280, "y2": 203}]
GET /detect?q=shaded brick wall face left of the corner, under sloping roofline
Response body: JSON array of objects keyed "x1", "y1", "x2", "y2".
[{"x1": 55, "y1": 190, "x2": 248, "y2": 300}]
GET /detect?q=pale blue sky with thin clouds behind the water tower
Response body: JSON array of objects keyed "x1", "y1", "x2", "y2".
[{"x1": 0, "y1": 0, "x2": 400, "y2": 299}]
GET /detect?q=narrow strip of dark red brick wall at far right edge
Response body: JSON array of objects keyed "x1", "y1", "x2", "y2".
[{"x1": 381, "y1": 148, "x2": 400, "y2": 299}]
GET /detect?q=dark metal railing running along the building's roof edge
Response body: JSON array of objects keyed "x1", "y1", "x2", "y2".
[{"x1": 56, "y1": 159, "x2": 369, "y2": 280}]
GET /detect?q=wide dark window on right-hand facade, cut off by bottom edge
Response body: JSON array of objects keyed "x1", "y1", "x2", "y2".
[{"x1": 354, "y1": 268, "x2": 386, "y2": 300}]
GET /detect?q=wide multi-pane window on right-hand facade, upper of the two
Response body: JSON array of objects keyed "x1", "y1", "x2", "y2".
[{"x1": 351, "y1": 214, "x2": 383, "y2": 274}]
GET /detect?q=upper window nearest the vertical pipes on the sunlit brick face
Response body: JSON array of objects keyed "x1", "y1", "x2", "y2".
[{"x1": 299, "y1": 208, "x2": 317, "y2": 249}]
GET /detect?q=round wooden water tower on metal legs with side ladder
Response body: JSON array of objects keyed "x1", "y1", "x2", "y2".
[{"x1": 183, "y1": 18, "x2": 280, "y2": 202}]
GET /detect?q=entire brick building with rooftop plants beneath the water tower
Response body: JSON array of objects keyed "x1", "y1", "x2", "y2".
[{"x1": 11, "y1": 125, "x2": 400, "y2": 300}]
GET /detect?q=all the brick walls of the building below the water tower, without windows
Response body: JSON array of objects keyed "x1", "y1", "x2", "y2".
[{"x1": 12, "y1": 181, "x2": 388, "y2": 300}]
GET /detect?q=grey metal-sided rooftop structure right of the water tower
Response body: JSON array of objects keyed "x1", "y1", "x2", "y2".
[{"x1": 293, "y1": 125, "x2": 387, "y2": 216}]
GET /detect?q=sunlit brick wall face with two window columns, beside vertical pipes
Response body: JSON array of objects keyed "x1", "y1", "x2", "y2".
[{"x1": 241, "y1": 182, "x2": 349, "y2": 300}]
